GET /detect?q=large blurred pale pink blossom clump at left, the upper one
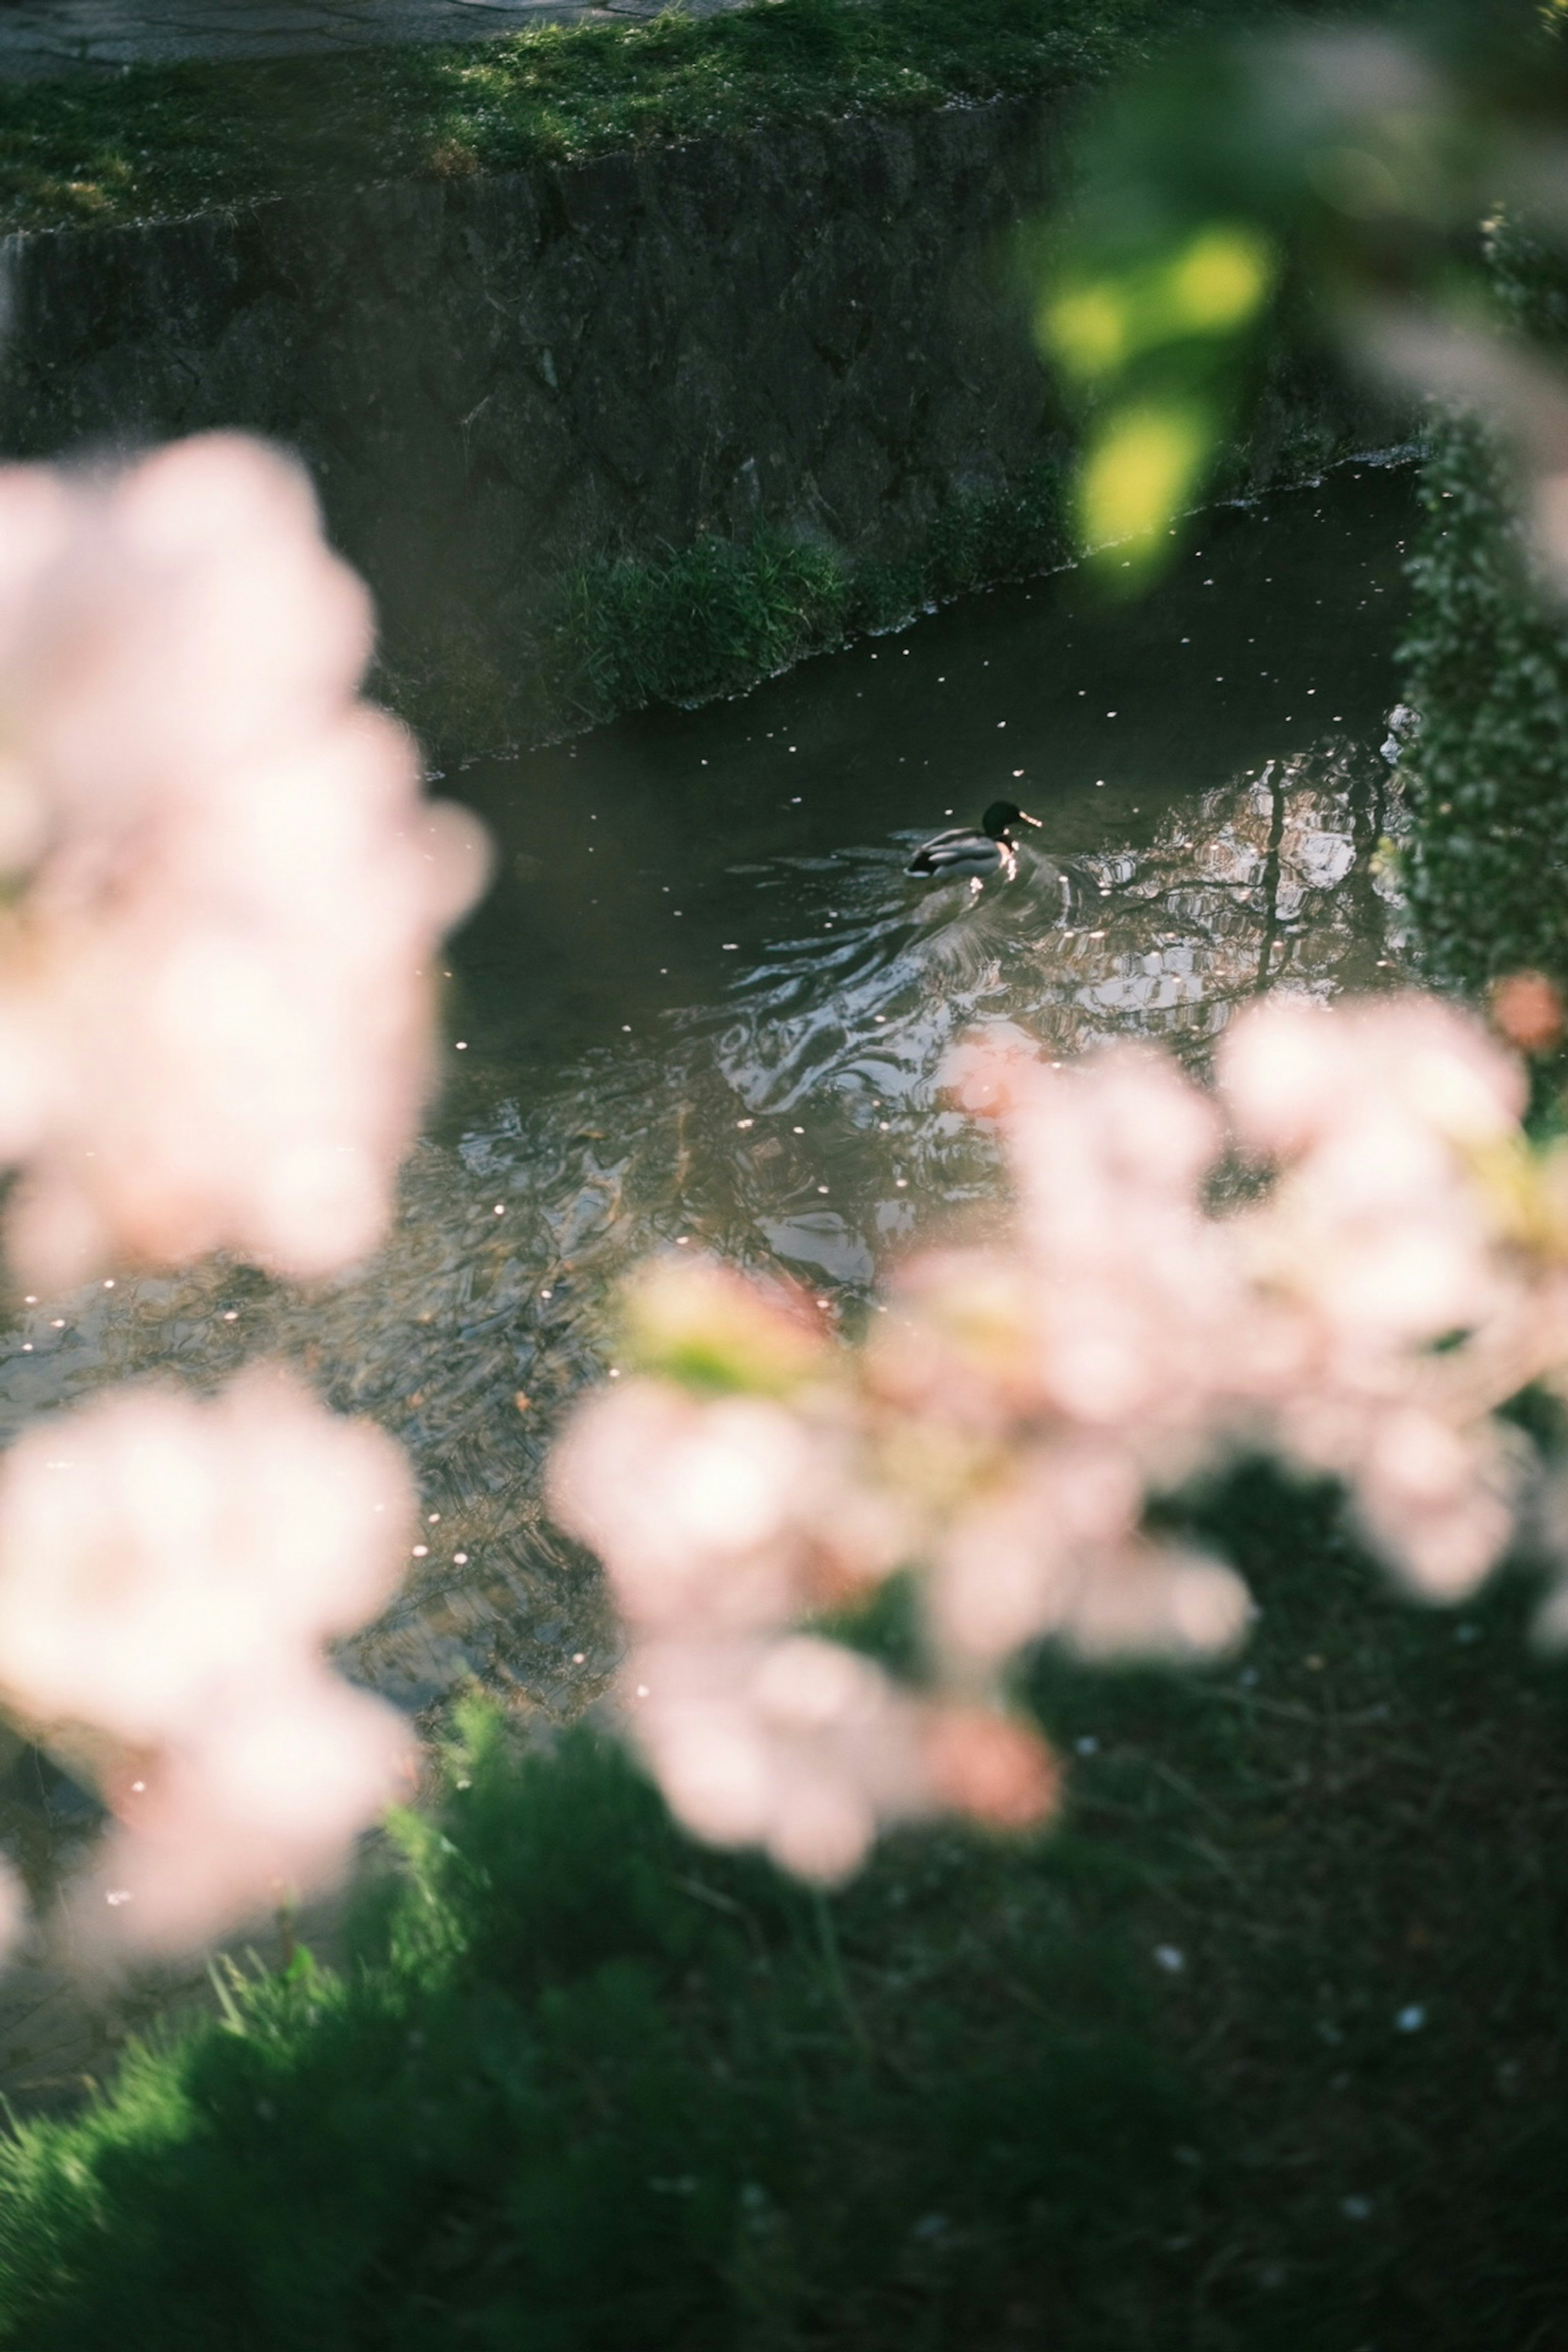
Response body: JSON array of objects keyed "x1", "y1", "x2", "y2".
[{"x1": 0, "y1": 435, "x2": 484, "y2": 1289}]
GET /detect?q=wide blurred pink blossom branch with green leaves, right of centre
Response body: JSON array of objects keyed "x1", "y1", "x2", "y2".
[{"x1": 550, "y1": 983, "x2": 1568, "y2": 1882}]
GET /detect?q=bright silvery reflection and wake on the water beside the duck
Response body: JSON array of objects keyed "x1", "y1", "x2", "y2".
[{"x1": 717, "y1": 739, "x2": 1401, "y2": 1105}]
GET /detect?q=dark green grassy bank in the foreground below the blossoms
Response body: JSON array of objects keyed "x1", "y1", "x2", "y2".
[{"x1": 0, "y1": 1470, "x2": 1568, "y2": 2352}]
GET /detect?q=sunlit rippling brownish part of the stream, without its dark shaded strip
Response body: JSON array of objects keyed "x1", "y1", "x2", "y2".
[{"x1": 0, "y1": 741, "x2": 1403, "y2": 1750}]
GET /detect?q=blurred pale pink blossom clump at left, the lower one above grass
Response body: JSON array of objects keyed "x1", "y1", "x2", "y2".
[{"x1": 0, "y1": 1367, "x2": 414, "y2": 1950}]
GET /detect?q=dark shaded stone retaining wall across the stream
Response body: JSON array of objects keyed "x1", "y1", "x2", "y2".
[{"x1": 0, "y1": 99, "x2": 1392, "y2": 729}]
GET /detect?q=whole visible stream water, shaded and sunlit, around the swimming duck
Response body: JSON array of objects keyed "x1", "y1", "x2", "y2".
[{"x1": 0, "y1": 449, "x2": 1415, "y2": 2051}]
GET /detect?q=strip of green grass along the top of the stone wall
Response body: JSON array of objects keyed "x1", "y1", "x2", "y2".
[{"x1": 0, "y1": 0, "x2": 1267, "y2": 228}]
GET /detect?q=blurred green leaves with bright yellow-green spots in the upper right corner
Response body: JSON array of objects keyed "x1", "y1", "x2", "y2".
[{"x1": 1025, "y1": 0, "x2": 1568, "y2": 593}]
